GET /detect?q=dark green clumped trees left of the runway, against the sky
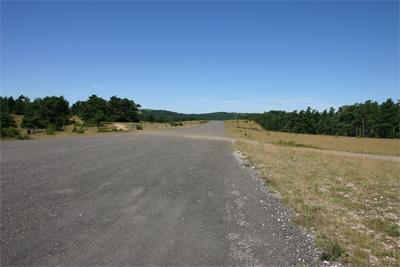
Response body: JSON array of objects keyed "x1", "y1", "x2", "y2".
[{"x1": 0, "y1": 95, "x2": 141, "y2": 137}]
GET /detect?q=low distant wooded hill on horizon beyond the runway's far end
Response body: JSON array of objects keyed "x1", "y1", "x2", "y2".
[{"x1": 140, "y1": 109, "x2": 253, "y2": 120}]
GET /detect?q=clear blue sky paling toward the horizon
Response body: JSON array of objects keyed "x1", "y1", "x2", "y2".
[{"x1": 1, "y1": 1, "x2": 400, "y2": 113}]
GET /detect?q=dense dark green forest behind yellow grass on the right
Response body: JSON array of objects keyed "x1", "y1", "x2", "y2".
[{"x1": 247, "y1": 98, "x2": 400, "y2": 138}]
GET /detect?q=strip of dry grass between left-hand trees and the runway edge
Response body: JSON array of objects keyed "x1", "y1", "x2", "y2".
[{"x1": 2, "y1": 115, "x2": 204, "y2": 141}]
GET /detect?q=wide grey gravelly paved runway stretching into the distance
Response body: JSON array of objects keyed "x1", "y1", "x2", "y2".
[{"x1": 1, "y1": 122, "x2": 322, "y2": 266}]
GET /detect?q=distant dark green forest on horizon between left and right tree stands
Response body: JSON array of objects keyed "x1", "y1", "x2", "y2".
[{"x1": 141, "y1": 109, "x2": 247, "y2": 122}]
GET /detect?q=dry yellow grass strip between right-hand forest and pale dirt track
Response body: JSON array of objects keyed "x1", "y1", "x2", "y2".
[{"x1": 225, "y1": 120, "x2": 400, "y2": 156}]
